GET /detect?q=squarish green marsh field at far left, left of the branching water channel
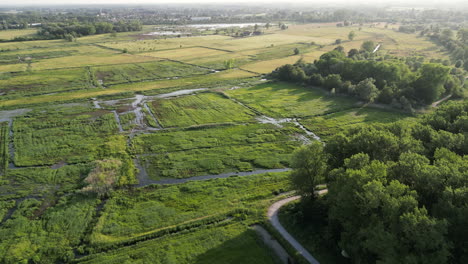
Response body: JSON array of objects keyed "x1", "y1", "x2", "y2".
[{"x1": 13, "y1": 105, "x2": 125, "y2": 166}]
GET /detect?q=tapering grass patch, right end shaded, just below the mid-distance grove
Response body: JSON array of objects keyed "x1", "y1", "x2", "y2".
[{"x1": 301, "y1": 108, "x2": 410, "y2": 139}]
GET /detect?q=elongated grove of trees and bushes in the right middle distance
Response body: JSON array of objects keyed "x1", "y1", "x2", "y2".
[{"x1": 271, "y1": 48, "x2": 464, "y2": 110}]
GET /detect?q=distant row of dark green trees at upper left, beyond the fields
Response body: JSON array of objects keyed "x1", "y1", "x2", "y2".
[{"x1": 38, "y1": 21, "x2": 142, "y2": 40}]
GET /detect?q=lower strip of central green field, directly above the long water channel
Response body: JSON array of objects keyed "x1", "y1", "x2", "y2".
[{"x1": 140, "y1": 141, "x2": 300, "y2": 179}]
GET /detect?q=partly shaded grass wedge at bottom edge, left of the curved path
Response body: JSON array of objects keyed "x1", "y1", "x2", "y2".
[{"x1": 78, "y1": 222, "x2": 277, "y2": 264}]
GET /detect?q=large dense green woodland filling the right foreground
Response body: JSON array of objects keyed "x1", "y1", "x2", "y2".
[{"x1": 291, "y1": 102, "x2": 468, "y2": 264}]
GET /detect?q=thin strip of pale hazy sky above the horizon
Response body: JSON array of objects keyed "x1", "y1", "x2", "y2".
[{"x1": 0, "y1": 0, "x2": 468, "y2": 7}]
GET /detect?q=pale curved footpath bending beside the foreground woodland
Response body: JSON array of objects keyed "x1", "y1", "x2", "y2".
[{"x1": 268, "y1": 195, "x2": 320, "y2": 264}]
